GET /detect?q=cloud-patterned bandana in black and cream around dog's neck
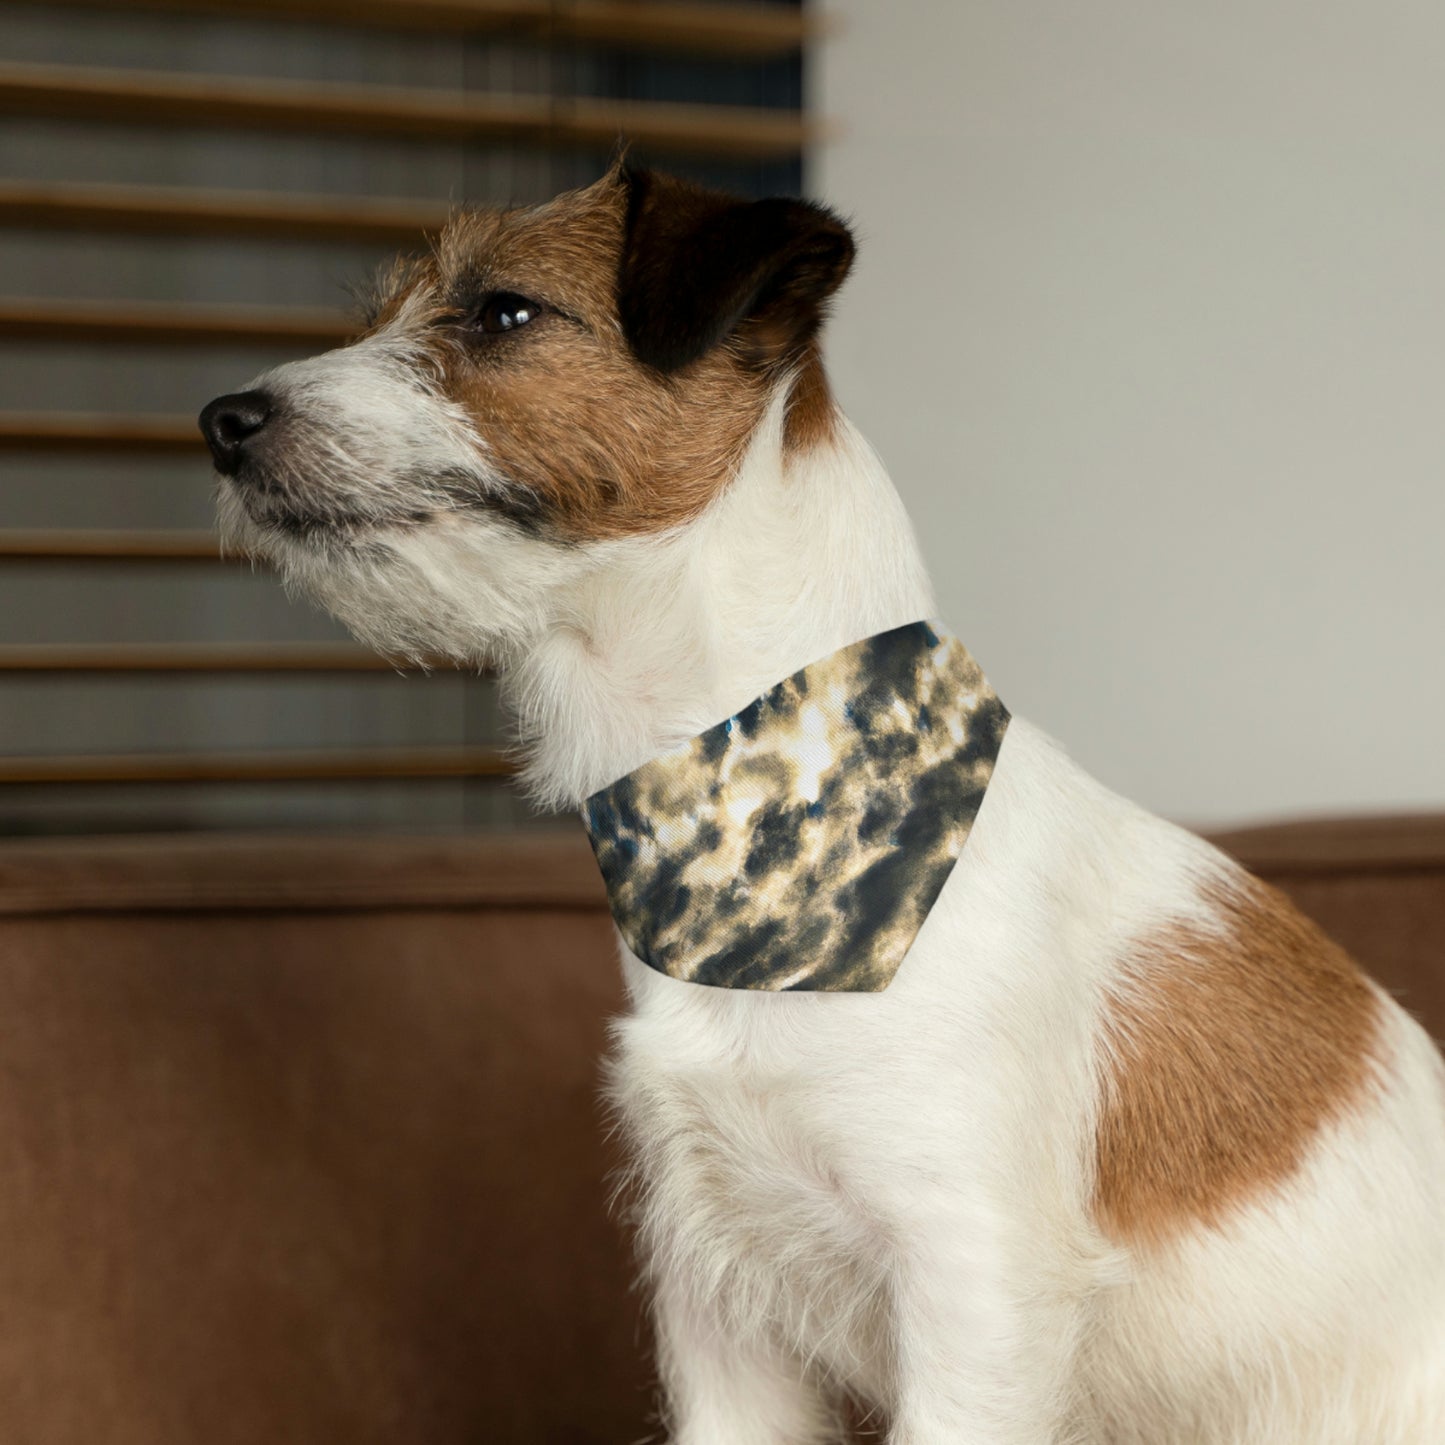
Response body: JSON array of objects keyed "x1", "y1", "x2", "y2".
[{"x1": 582, "y1": 623, "x2": 1009, "y2": 993}]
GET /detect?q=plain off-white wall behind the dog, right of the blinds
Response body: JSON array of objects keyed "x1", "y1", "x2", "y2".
[{"x1": 809, "y1": 0, "x2": 1445, "y2": 822}]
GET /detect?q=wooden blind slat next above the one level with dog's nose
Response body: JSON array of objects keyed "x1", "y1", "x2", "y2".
[{"x1": 0, "y1": 296, "x2": 357, "y2": 348}]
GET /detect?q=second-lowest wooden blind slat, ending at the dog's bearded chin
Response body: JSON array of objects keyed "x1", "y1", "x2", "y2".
[{"x1": 0, "y1": 642, "x2": 419, "y2": 675}]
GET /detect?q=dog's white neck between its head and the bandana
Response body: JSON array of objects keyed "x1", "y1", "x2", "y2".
[{"x1": 504, "y1": 399, "x2": 933, "y2": 808}]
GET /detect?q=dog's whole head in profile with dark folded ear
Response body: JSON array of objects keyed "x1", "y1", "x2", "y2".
[{"x1": 201, "y1": 166, "x2": 853, "y2": 657}]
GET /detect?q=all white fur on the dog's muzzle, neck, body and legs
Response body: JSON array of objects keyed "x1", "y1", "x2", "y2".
[{"x1": 213, "y1": 225, "x2": 1445, "y2": 1445}]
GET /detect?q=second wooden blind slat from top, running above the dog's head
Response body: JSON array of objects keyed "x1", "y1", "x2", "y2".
[{"x1": 0, "y1": 64, "x2": 818, "y2": 160}]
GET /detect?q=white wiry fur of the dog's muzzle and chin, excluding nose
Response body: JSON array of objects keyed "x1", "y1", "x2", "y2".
[{"x1": 217, "y1": 308, "x2": 582, "y2": 662}]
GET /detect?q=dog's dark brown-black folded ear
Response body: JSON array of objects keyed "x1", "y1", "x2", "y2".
[{"x1": 617, "y1": 166, "x2": 854, "y2": 373}]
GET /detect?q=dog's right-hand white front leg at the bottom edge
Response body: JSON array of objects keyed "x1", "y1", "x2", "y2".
[{"x1": 889, "y1": 1234, "x2": 1087, "y2": 1445}]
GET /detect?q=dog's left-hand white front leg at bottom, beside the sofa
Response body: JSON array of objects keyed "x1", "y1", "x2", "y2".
[{"x1": 653, "y1": 1280, "x2": 841, "y2": 1445}]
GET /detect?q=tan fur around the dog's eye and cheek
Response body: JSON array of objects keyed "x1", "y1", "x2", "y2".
[{"x1": 379, "y1": 176, "x2": 767, "y2": 540}]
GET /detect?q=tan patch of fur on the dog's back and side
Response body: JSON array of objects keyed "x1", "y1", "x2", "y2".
[{"x1": 1094, "y1": 879, "x2": 1380, "y2": 1244}]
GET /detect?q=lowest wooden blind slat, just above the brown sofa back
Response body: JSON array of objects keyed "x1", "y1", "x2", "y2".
[{"x1": 0, "y1": 747, "x2": 516, "y2": 785}]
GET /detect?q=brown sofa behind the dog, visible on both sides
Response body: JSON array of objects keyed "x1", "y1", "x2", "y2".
[{"x1": 0, "y1": 818, "x2": 1445, "y2": 1445}]
